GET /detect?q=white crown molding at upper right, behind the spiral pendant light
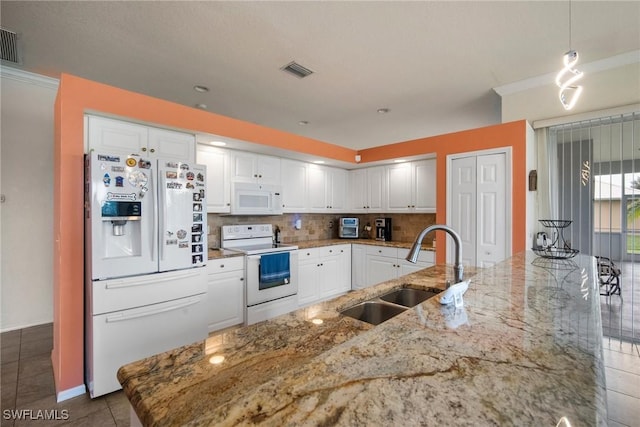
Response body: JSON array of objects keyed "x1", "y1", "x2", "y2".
[{"x1": 493, "y1": 49, "x2": 640, "y2": 96}]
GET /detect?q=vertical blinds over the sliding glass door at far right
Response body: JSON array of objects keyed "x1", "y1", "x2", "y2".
[{"x1": 538, "y1": 112, "x2": 640, "y2": 343}]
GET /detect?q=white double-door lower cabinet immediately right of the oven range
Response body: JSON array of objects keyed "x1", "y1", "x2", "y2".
[{"x1": 298, "y1": 245, "x2": 351, "y2": 307}]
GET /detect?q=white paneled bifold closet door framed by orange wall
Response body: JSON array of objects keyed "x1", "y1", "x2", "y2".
[{"x1": 447, "y1": 150, "x2": 511, "y2": 267}]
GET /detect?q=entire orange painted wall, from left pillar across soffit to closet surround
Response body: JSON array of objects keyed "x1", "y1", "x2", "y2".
[{"x1": 52, "y1": 74, "x2": 525, "y2": 393}]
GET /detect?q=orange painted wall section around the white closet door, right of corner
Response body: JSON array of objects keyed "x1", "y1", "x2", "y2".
[{"x1": 359, "y1": 120, "x2": 527, "y2": 263}]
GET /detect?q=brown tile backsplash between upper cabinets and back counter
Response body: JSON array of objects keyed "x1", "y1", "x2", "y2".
[{"x1": 207, "y1": 213, "x2": 436, "y2": 248}]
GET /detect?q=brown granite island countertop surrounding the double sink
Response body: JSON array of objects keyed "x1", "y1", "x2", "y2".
[{"x1": 118, "y1": 252, "x2": 607, "y2": 426}]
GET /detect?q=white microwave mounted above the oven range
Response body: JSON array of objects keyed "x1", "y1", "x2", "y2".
[{"x1": 231, "y1": 182, "x2": 282, "y2": 215}]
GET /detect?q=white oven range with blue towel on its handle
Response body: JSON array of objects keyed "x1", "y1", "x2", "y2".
[{"x1": 221, "y1": 224, "x2": 298, "y2": 325}]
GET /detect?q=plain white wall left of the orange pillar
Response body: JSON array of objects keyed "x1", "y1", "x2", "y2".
[{"x1": 0, "y1": 67, "x2": 58, "y2": 331}]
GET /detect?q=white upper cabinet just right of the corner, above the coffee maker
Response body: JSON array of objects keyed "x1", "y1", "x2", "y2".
[{"x1": 348, "y1": 166, "x2": 385, "y2": 213}]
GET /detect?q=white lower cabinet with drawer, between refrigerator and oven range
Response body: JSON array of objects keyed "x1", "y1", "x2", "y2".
[{"x1": 207, "y1": 257, "x2": 245, "y2": 332}]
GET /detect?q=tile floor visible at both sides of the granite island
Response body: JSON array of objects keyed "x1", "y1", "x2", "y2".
[{"x1": 0, "y1": 324, "x2": 640, "y2": 427}]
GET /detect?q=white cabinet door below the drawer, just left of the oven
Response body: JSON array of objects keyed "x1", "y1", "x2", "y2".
[{"x1": 207, "y1": 270, "x2": 244, "y2": 332}]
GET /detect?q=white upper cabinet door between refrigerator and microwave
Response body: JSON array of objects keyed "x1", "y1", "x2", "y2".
[{"x1": 197, "y1": 144, "x2": 231, "y2": 213}]
